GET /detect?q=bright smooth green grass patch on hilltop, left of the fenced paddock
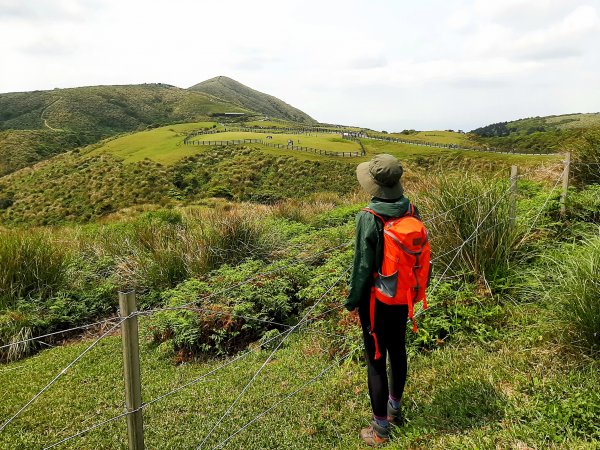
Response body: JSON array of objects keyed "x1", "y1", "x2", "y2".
[{"x1": 90, "y1": 122, "x2": 216, "y2": 165}]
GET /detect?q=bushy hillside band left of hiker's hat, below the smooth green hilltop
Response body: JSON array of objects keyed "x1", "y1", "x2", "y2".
[{"x1": 0, "y1": 143, "x2": 355, "y2": 225}]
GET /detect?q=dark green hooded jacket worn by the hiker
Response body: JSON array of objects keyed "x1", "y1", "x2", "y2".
[{"x1": 344, "y1": 197, "x2": 418, "y2": 311}]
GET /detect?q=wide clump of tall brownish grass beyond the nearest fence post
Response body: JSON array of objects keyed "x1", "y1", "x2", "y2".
[{"x1": 88, "y1": 208, "x2": 280, "y2": 293}]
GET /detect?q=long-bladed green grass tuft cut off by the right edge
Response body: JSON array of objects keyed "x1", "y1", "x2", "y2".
[{"x1": 551, "y1": 237, "x2": 600, "y2": 354}]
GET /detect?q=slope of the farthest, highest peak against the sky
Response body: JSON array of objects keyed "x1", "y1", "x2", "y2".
[{"x1": 189, "y1": 76, "x2": 316, "y2": 123}]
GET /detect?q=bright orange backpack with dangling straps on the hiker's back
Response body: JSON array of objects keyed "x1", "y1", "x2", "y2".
[{"x1": 363, "y1": 204, "x2": 431, "y2": 359}]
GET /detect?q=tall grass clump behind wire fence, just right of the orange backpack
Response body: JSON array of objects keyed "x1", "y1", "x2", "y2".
[{"x1": 418, "y1": 174, "x2": 518, "y2": 288}]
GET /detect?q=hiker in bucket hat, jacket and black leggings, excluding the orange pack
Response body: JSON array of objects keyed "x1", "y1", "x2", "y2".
[{"x1": 344, "y1": 154, "x2": 429, "y2": 446}]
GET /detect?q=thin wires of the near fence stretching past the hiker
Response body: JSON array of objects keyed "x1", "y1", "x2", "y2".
[{"x1": 0, "y1": 169, "x2": 564, "y2": 449}]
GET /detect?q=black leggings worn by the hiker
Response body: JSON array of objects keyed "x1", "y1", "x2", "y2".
[{"x1": 358, "y1": 301, "x2": 408, "y2": 417}]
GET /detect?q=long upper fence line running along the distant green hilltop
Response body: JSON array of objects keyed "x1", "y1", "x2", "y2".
[{"x1": 183, "y1": 127, "x2": 558, "y2": 156}]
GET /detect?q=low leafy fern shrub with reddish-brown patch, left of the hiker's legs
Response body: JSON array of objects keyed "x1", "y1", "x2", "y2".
[{"x1": 149, "y1": 261, "x2": 310, "y2": 358}]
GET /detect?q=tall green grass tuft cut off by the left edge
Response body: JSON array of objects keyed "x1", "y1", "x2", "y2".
[{"x1": 0, "y1": 230, "x2": 69, "y2": 308}]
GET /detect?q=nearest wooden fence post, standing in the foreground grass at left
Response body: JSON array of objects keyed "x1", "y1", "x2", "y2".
[{"x1": 119, "y1": 291, "x2": 144, "y2": 450}]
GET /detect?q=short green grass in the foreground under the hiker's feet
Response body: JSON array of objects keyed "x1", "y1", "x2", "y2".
[{"x1": 0, "y1": 298, "x2": 600, "y2": 450}]
